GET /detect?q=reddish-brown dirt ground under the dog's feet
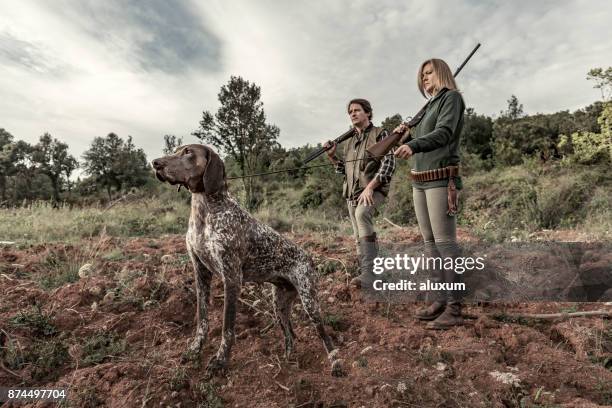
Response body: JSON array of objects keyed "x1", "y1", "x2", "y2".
[{"x1": 0, "y1": 230, "x2": 612, "y2": 408}]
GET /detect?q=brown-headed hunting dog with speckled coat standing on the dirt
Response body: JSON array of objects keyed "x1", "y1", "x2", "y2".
[{"x1": 153, "y1": 144, "x2": 343, "y2": 375}]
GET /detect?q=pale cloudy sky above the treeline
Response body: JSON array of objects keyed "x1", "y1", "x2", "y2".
[{"x1": 0, "y1": 0, "x2": 612, "y2": 165}]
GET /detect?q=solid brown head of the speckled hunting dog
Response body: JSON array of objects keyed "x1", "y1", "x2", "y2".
[{"x1": 152, "y1": 144, "x2": 227, "y2": 194}]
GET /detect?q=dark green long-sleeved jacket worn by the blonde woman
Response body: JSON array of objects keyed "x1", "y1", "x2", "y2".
[{"x1": 406, "y1": 90, "x2": 465, "y2": 189}]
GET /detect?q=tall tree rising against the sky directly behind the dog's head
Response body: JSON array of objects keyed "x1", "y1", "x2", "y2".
[{"x1": 192, "y1": 76, "x2": 280, "y2": 209}]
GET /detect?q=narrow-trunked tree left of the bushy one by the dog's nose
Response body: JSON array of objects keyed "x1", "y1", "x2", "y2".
[{"x1": 32, "y1": 133, "x2": 79, "y2": 203}]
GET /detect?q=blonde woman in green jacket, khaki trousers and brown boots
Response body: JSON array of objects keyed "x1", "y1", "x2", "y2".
[{"x1": 395, "y1": 59, "x2": 465, "y2": 329}]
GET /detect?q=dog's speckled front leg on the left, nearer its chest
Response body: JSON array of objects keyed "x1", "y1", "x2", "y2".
[{"x1": 183, "y1": 250, "x2": 212, "y2": 361}]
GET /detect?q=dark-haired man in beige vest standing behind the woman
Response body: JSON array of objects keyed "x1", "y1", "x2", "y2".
[{"x1": 325, "y1": 99, "x2": 395, "y2": 287}]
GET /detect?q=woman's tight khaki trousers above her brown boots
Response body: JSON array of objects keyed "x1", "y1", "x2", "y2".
[{"x1": 412, "y1": 187, "x2": 463, "y2": 303}]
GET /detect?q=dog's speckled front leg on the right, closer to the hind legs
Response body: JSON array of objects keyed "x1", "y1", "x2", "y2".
[{"x1": 207, "y1": 272, "x2": 241, "y2": 374}]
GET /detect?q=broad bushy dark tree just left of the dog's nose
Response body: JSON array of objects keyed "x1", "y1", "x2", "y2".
[{"x1": 83, "y1": 133, "x2": 150, "y2": 200}]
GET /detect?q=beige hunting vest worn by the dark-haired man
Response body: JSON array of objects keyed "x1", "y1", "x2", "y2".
[{"x1": 342, "y1": 126, "x2": 389, "y2": 199}]
